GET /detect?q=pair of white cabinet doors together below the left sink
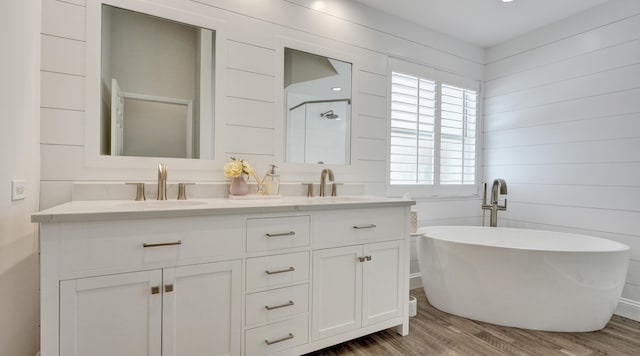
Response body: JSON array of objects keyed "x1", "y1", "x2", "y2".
[{"x1": 60, "y1": 261, "x2": 241, "y2": 356}]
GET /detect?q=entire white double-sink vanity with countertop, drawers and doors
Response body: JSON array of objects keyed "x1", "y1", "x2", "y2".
[{"x1": 32, "y1": 198, "x2": 413, "y2": 356}]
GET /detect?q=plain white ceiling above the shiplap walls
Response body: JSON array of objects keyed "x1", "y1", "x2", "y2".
[{"x1": 356, "y1": 0, "x2": 609, "y2": 47}]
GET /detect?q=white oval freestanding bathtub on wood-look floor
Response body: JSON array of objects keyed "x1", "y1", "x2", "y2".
[{"x1": 417, "y1": 226, "x2": 629, "y2": 332}]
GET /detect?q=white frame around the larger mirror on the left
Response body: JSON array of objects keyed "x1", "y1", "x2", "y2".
[{"x1": 84, "y1": 0, "x2": 227, "y2": 171}]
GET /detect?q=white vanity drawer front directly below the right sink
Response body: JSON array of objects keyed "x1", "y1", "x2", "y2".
[{"x1": 313, "y1": 207, "x2": 408, "y2": 248}]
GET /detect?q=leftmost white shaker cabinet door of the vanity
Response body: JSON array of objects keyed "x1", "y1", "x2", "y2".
[{"x1": 60, "y1": 270, "x2": 162, "y2": 356}]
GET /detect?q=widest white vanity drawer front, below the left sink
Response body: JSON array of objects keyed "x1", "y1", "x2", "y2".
[{"x1": 59, "y1": 216, "x2": 243, "y2": 278}]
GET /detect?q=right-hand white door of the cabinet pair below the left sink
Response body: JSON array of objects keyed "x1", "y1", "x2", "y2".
[{"x1": 162, "y1": 261, "x2": 242, "y2": 356}]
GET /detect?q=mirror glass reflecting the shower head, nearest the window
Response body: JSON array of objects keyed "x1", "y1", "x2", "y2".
[{"x1": 284, "y1": 48, "x2": 352, "y2": 165}]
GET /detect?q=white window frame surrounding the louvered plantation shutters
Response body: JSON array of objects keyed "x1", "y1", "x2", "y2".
[{"x1": 386, "y1": 58, "x2": 482, "y2": 198}]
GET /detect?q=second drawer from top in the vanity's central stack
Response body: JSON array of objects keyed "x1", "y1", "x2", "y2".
[{"x1": 246, "y1": 252, "x2": 309, "y2": 291}]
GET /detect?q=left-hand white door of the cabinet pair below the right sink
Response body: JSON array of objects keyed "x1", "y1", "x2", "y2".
[{"x1": 312, "y1": 246, "x2": 363, "y2": 340}]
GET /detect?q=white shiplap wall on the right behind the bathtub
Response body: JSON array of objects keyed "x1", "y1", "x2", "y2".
[{"x1": 483, "y1": 0, "x2": 640, "y2": 319}]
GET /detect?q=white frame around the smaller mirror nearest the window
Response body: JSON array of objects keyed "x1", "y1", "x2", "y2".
[{"x1": 274, "y1": 37, "x2": 360, "y2": 177}]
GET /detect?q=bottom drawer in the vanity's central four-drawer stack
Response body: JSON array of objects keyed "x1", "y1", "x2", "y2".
[{"x1": 245, "y1": 314, "x2": 309, "y2": 356}]
